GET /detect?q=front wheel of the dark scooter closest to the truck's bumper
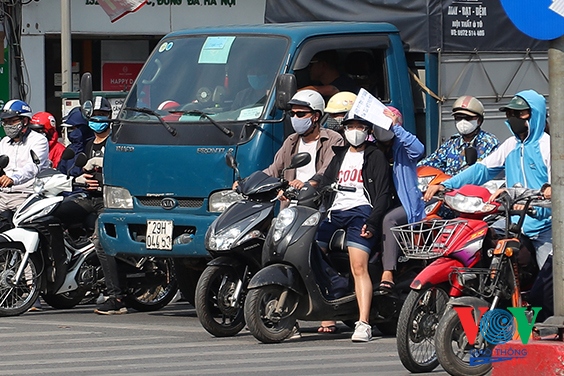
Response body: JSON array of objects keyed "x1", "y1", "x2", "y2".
[{"x1": 195, "y1": 266, "x2": 246, "y2": 337}]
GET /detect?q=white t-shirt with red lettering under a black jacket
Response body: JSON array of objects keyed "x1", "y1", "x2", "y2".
[{"x1": 329, "y1": 150, "x2": 372, "y2": 214}]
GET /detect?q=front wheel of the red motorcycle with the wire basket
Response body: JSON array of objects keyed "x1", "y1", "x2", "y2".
[{"x1": 396, "y1": 286, "x2": 448, "y2": 373}]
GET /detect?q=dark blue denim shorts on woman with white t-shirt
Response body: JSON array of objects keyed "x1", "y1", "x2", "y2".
[{"x1": 317, "y1": 205, "x2": 376, "y2": 254}]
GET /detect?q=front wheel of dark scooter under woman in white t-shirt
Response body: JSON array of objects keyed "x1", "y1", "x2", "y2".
[{"x1": 245, "y1": 285, "x2": 298, "y2": 343}]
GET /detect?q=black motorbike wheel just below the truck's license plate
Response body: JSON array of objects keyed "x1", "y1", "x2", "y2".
[{"x1": 124, "y1": 258, "x2": 178, "y2": 312}]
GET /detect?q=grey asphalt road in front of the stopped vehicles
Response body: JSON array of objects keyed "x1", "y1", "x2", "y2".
[{"x1": 0, "y1": 302, "x2": 446, "y2": 376}]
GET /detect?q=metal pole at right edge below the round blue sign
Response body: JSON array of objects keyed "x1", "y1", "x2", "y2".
[{"x1": 548, "y1": 37, "x2": 564, "y2": 317}]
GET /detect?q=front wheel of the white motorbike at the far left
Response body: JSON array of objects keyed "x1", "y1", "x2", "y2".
[{"x1": 0, "y1": 247, "x2": 43, "y2": 316}]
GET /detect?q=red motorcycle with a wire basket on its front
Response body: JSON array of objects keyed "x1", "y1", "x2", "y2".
[{"x1": 392, "y1": 185, "x2": 499, "y2": 373}]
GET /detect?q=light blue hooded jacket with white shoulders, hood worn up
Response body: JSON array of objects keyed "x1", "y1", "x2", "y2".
[{"x1": 443, "y1": 90, "x2": 552, "y2": 237}]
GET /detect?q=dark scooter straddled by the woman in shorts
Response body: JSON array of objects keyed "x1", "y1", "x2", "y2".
[{"x1": 245, "y1": 187, "x2": 423, "y2": 343}]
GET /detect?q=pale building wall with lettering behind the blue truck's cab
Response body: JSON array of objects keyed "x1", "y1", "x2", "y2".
[{"x1": 21, "y1": 0, "x2": 266, "y2": 116}]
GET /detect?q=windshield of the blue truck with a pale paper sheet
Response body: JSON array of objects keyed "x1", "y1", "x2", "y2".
[{"x1": 119, "y1": 35, "x2": 288, "y2": 130}]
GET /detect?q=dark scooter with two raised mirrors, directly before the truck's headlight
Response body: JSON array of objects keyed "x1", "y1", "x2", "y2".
[{"x1": 195, "y1": 153, "x2": 311, "y2": 337}]
